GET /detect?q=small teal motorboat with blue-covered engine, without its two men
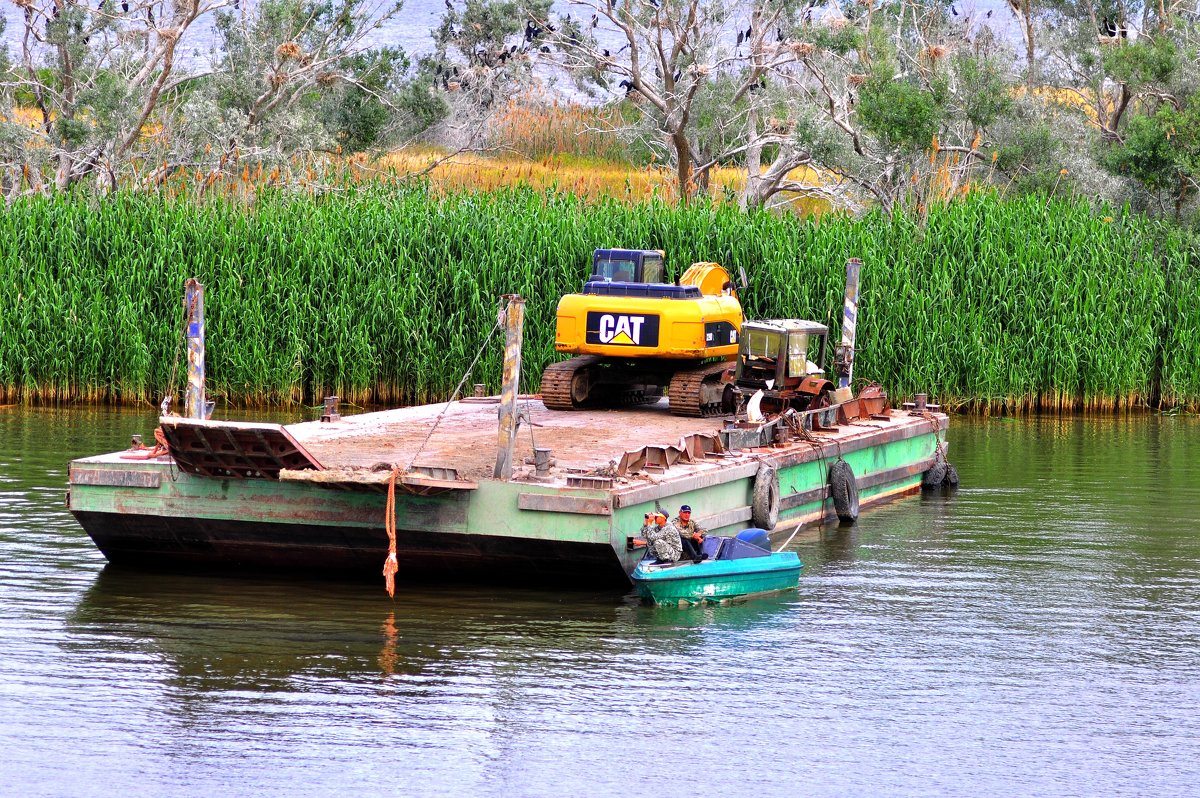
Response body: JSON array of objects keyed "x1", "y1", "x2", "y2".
[{"x1": 632, "y1": 529, "x2": 802, "y2": 605}]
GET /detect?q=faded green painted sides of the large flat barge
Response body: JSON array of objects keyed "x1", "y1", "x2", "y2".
[{"x1": 70, "y1": 420, "x2": 944, "y2": 583}]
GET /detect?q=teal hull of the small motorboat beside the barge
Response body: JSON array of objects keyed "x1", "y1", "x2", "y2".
[{"x1": 632, "y1": 552, "x2": 802, "y2": 605}]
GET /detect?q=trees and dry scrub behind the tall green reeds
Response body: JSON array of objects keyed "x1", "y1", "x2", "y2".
[{"x1": 0, "y1": 0, "x2": 1200, "y2": 224}]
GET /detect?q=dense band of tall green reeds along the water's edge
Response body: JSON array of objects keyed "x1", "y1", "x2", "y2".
[{"x1": 0, "y1": 186, "x2": 1200, "y2": 412}]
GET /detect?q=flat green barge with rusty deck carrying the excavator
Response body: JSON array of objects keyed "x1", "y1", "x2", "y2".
[{"x1": 68, "y1": 397, "x2": 947, "y2": 586}]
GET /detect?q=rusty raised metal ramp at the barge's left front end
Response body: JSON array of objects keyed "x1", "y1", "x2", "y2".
[{"x1": 158, "y1": 416, "x2": 324, "y2": 480}]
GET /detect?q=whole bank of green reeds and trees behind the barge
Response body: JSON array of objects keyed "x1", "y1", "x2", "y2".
[{"x1": 0, "y1": 0, "x2": 1200, "y2": 412}]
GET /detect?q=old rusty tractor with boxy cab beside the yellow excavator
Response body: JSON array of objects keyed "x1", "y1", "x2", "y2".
[{"x1": 733, "y1": 319, "x2": 834, "y2": 413}]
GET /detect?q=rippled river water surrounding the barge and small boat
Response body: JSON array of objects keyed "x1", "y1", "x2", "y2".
[{"x1": 0, "y1": 408, "x2": 1200, "y2": 798}]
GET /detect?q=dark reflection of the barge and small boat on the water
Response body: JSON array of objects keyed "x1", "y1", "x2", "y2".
[{"x1": 62, "y1": 566, "x2": 796, "y2": 694}]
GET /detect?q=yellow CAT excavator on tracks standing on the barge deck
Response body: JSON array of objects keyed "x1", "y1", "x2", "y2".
[{"x1": 541, "y1": 250, "x2": 743, "y2": 416}]
